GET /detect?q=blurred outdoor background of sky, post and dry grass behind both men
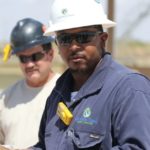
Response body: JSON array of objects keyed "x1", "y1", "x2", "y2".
[{"x1": 0, "y1": 0, "x2": 150, "y2": 89}]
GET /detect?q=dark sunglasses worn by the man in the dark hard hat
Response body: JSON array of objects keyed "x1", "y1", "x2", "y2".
[{"x1": 18, "y1": 52, "x2": 45, "y2": 63}]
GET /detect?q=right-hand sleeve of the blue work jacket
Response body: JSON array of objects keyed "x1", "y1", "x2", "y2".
[{"x1": 111, "y1": 74, "x2": 150, "y2": 150}]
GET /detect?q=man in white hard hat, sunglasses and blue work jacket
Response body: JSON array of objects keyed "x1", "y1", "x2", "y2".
[{"x1": 2, "y1": 0, "x2": 150, "y2": 150}]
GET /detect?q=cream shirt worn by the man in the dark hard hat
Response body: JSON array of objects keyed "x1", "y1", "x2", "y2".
[{"x1": 0, "y1": 74, "x2": 60, "y2": 149}]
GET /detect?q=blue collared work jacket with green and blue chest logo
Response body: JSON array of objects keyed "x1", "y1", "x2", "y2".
[{"x1": 32, "y1": 54, "x2": 150, "y2": 150}]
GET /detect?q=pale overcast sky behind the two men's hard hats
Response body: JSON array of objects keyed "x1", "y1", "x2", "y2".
[{"x1": 0, "y1": 0, "x2": 150, "y2": 42}]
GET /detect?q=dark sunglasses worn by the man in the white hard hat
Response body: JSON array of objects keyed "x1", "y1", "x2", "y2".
[{"x1": 56, "y1": 31, "x2": 102, "y2": 46}]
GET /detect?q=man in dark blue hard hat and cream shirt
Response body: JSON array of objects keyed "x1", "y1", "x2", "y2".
[{"x1": 0, "y1": 18, "x2": 60, "y2": 149}]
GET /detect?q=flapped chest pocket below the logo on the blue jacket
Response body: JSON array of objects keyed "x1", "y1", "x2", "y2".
[{"x1": 67, "y1": 129, "x2": 105, "y2": 150}]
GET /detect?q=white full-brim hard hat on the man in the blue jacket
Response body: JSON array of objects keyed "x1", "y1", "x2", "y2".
[{"x1": 44, "y1": 0, "x2": 116, "y2": 36}]
